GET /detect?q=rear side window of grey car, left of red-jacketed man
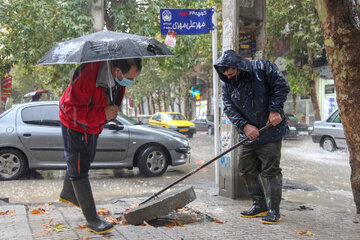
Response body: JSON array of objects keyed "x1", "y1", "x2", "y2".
[{"x1": 21, "y1": 105, "x2": 60, "y2": 126}]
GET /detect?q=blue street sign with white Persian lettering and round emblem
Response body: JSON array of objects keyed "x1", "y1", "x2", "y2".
[{"x1": 160, "y1": 8, "x2": 214, "y2": 35}]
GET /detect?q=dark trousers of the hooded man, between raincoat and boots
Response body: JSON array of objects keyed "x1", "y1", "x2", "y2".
[{"x1": 238, "y1": 140, "x2": 281, "y2": 177}]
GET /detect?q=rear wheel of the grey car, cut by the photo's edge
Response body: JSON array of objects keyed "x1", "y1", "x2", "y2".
[{"x1": 0, "y1": 149, "x2": 28, "y2": 180}]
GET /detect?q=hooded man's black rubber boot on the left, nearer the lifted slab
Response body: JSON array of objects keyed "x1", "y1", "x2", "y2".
[{"x1": 240, "y1": 175, "x2": 268, "y2": 218}]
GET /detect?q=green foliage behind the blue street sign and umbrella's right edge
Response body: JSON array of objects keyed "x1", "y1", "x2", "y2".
[{"x1": 107, "y1": 0, "x2": 222, "y2": 107}]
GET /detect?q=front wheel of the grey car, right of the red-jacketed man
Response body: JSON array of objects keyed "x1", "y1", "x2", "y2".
[{"x1": 138, "y1": 146, "x2": 168, "y2": 177}]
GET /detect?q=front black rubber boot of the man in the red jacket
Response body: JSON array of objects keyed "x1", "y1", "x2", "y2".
[{"x1": 72, "y1": 177, "x2": 114, "y2": 234}]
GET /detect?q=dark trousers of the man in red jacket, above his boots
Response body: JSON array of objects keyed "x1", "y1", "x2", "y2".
[{"x1": 61, "y1": 124, "x2": 99, "y2": 180}]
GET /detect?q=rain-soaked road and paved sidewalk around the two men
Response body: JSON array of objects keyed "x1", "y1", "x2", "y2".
[{"x1": 0, "y1": 134, "x2": 360, "y2": 239}]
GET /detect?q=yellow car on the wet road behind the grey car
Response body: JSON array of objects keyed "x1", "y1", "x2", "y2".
[{"x1": 149, "y1": 112, "x2": 196, "y2": 138}]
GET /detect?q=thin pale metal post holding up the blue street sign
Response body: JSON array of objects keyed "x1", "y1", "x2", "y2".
[{"x1": 212, "y1": 6, "x2": 220, "y2": 186}]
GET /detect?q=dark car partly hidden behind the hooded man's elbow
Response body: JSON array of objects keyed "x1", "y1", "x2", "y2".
[{"x1": 284, "y1": 113, "x2": 313, "y2": 139}]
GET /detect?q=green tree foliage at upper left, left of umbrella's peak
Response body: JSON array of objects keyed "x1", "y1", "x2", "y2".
[{"x1": 0, "y1": 0, "x2": 92, "y2": 99}]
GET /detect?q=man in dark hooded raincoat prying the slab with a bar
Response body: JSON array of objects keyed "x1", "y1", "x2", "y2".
[{"x1": 214, "y1": 50, "x2": 290, "y2": 224}]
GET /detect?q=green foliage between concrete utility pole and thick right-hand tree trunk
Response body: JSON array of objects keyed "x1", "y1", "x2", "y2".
[{"x1": 266, "y1": 0, "x2": 323, "y2": 95}]
